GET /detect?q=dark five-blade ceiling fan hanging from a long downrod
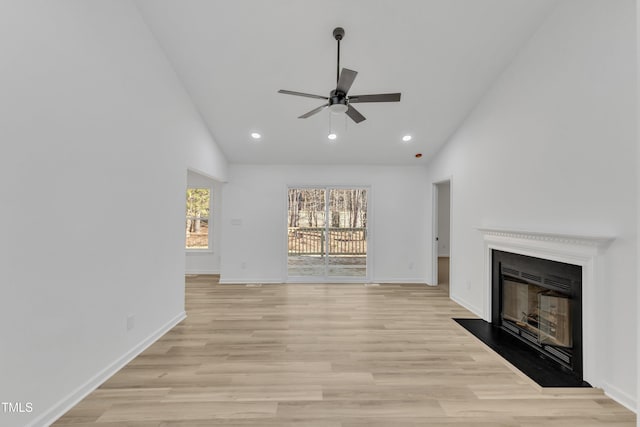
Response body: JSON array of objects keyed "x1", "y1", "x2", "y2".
[{"x1": 278, "y1": 27, "x2": 400, "y2": 123}]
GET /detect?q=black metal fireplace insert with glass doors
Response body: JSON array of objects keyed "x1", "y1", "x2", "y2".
[{"x1": 491, "y1": 249, "x2": 583, "y2": 380}]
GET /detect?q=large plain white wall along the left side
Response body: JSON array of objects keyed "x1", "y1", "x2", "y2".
[{"x1": 0, "y1": 0, "x2": 224, "y2": 425}]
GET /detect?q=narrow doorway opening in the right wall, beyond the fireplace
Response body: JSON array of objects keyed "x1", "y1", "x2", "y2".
[{"x1": 432, "y1": 180, "x2": 451, "y2": 288}]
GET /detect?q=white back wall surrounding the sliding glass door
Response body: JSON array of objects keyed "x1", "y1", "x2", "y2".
[{"x1": 221, "y1": 165, "x2": 431, "y2": 283}]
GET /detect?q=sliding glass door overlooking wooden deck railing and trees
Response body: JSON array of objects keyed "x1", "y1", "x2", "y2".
[{"x1": 287, "y1": 187, "x2": 369, "y2": 281}]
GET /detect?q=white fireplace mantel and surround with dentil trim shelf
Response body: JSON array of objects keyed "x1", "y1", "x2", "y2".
[{"x1": 478, "y1": 227, "x2": 614, "y2": 388}]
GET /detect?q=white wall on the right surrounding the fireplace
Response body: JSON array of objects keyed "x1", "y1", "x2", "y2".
[{"x1": 429, "y1": 0, "x2": 638, "y2": 407}]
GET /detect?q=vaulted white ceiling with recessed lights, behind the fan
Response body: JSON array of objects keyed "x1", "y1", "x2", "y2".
[{"x1": 137, "y1": 0, "x2": 556, "y2": 165}]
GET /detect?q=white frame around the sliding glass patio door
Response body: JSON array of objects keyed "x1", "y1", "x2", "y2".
[{"x1": 282, "y1": 184, "x2": 374, "y2": 283}]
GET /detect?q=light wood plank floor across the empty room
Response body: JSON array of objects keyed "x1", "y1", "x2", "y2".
[{"x1": 55, "y1": 276, "x2": 635, "y2": 427}]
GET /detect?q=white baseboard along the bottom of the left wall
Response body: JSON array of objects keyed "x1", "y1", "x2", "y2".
[{"x1": 27, "y1": 311, "x2": 187, "y2": 427}]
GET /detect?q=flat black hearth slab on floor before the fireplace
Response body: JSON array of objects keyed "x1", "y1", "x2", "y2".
[{"x1": 453, "y1": 319, "x2": 591, "y2": 387}]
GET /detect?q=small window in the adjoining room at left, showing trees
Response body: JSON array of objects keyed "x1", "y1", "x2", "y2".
[{"x1": 186, "y1": 188, "x2": 211, "y2": 249}]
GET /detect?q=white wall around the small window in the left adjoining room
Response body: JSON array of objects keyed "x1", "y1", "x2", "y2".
[{"x1": 185, "y1": 171, "x2": 223, "y2": 274}]
